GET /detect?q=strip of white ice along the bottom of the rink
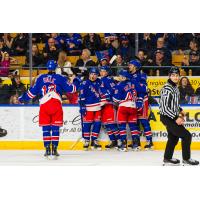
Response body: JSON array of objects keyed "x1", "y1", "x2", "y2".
[{"x1": 0, "y1": 150, "x2": 200, "y2": 166}]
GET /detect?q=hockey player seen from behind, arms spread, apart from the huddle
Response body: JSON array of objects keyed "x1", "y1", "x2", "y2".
[{"x1": 19, "y1": 60, "x2": 76, "y2": 157}]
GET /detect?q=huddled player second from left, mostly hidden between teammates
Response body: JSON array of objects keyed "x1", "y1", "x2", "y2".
[{"x1": 100, "y1": 66, "x2": 120, "y2": 149}]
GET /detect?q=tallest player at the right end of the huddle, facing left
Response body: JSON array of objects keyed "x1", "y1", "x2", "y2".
[{"x1": 128, "y1": 60, "x2": 153, "y2": 150}]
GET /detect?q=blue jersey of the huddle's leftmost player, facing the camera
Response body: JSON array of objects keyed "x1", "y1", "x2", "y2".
[{"x1": 80, "y1": 79, "x2": 109, "y2": 111}]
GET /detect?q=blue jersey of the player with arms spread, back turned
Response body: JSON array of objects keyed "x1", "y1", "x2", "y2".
[{"x1": 19, "y1": 74, "x2": 76, "y2": 104}]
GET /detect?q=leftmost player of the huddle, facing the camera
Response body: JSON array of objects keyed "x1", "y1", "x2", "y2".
[{"x1": 80, "y1": 67, "x2": 107, "y2": 150}]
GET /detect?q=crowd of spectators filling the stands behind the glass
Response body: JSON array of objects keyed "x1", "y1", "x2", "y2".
[{"x1": 0, "y1": 33, "x2": 200, "y2": 104}]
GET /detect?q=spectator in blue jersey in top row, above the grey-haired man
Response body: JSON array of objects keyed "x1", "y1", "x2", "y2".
[{"x1": 65, "y1": 33, "x2": 82, "y2": 56}]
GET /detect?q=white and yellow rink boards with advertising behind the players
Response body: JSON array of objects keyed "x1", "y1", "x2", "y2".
[{"x1": 0, "y1": 105, "x2": 200, "y2": 150}]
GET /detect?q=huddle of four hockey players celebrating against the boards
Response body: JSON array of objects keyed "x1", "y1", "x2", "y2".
[{"x1": 80, "y1": 60, "x2": 153, "y2": 151}]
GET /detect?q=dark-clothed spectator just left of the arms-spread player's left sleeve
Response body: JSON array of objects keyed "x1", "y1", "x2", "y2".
[{"x1": 10, "y1": 75, "x2": 26, "y2": 96}]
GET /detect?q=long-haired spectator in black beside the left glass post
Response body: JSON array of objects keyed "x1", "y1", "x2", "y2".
[{"x1": 31, "y1": 44, "x2": 44, "y2": 68}]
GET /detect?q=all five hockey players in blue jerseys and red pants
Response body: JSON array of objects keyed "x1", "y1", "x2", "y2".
[{"x1": 19, "y1": 60, "x2": 153, "y2": 157}]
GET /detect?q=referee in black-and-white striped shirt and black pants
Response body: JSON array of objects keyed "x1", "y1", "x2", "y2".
[{"x1": 159, "y1": 67, "x2": 199, "y2": 165}]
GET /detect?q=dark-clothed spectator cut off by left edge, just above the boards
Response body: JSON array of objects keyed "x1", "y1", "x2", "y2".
[{"x1": 0, "y1": 78, "x2": 11, "y2": 104}]
